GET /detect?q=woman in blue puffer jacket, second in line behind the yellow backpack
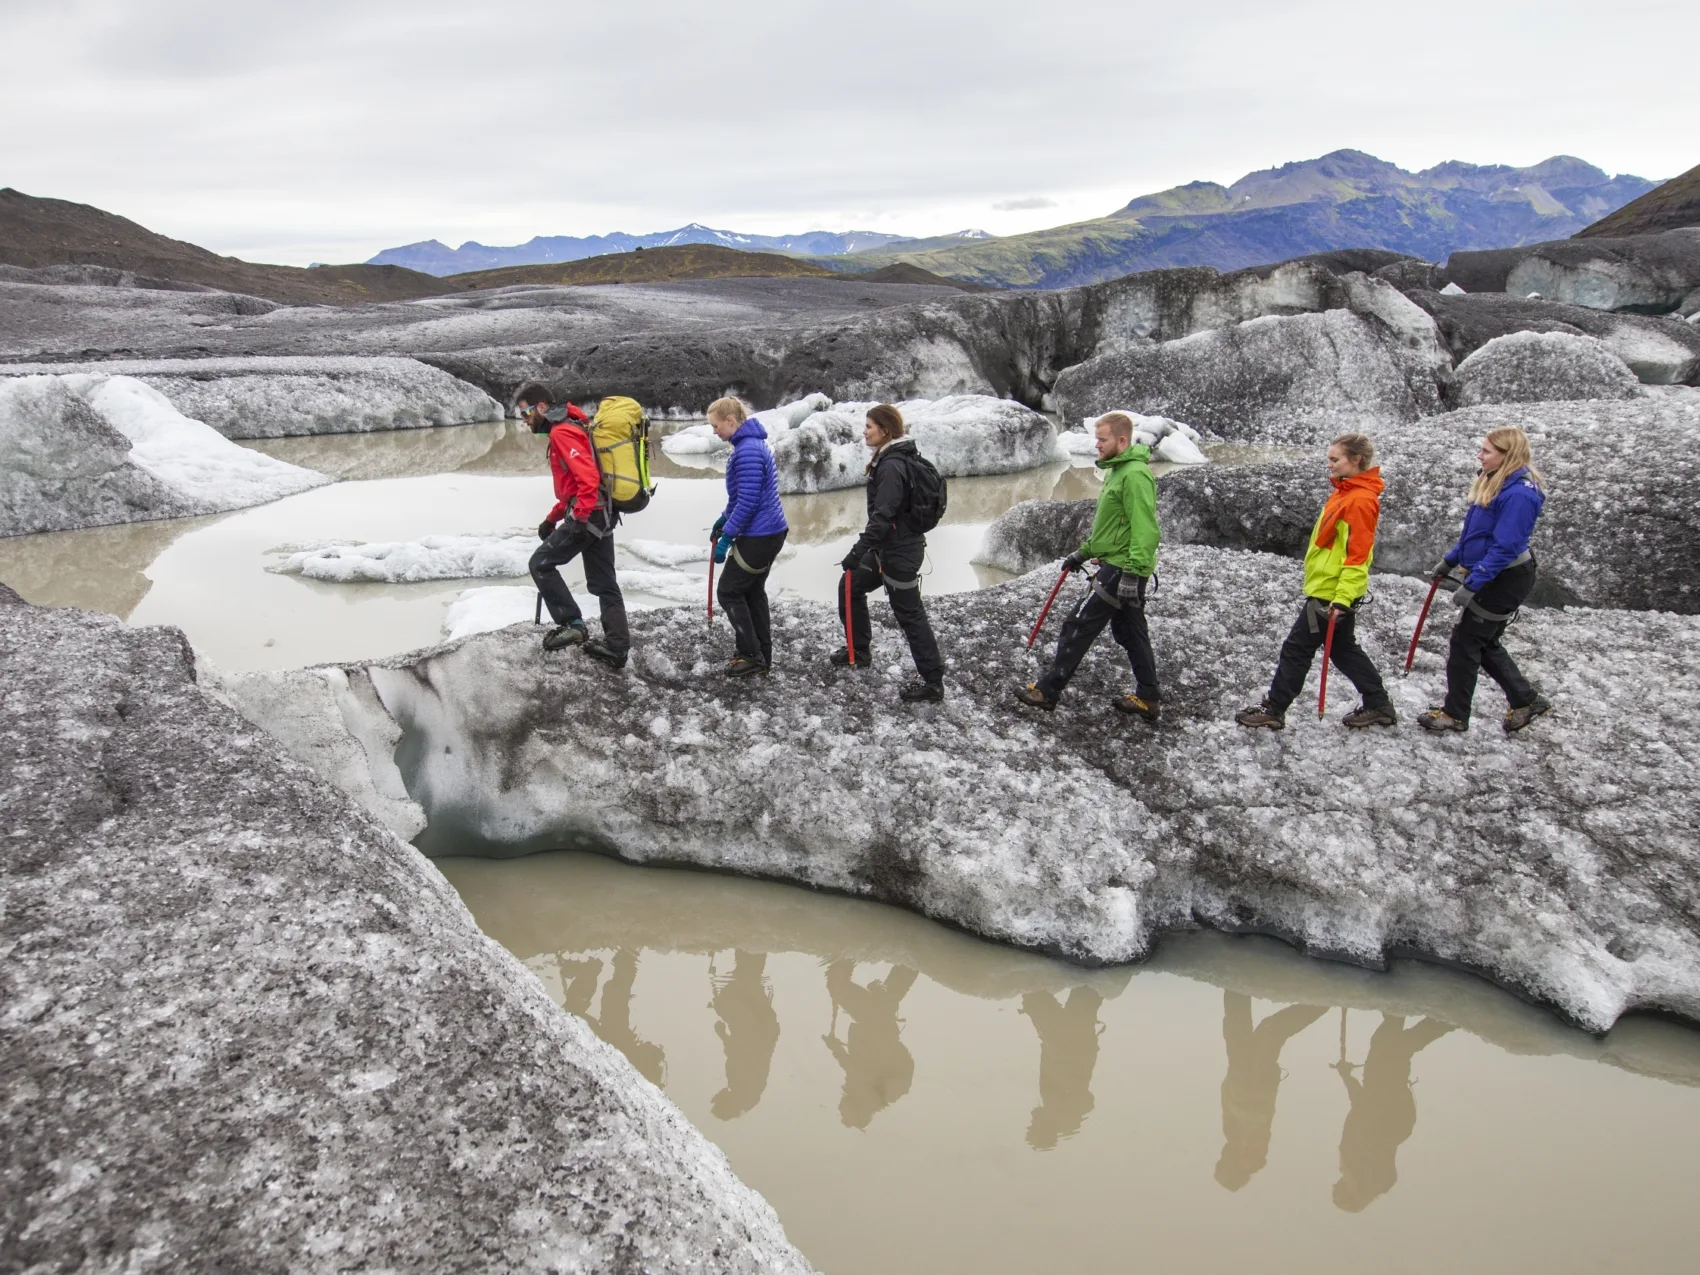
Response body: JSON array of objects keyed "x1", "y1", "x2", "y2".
[{"x1": 709, "y1": 398, "x2": 791, "y2": 677}]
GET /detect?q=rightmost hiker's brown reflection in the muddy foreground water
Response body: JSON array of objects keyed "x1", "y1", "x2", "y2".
[{"x1": 1335, "y1": 1013, "x2": 1452, "y2": 1214}]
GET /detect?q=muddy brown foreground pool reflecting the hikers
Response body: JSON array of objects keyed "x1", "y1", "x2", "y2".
[{"x1": 437, "y1": 853, "x2": 1700, "y2": 1275}]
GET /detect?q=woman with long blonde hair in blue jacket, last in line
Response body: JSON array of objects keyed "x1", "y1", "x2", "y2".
[{"x1": 1416, "y1": 428, "x2": 1552, "y2": 731}]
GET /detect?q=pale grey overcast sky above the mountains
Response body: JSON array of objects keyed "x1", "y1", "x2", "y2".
[{"x1": 0, "y1": 0, "x2": 1700, "y2": 264}]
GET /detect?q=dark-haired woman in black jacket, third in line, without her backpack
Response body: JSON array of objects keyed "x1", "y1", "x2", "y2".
[{"x1": 833, "y1": 403, "x2": 945, "y2": 704}]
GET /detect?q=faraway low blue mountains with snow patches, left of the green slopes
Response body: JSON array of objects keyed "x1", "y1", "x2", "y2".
[{"x1": 367, "y1": 221, "x2": 991, "y2": 275}]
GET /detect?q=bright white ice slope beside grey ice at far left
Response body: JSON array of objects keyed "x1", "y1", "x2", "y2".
[{"x1": 63, "y1": 374, "x2": 332, "y2": 510}]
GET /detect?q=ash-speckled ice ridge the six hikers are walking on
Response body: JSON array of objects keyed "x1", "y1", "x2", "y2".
[{"x1": 231, "y1": 546, "x2": 1700, "y2": 1032}]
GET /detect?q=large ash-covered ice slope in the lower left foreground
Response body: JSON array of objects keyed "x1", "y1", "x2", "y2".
[{"x1": 0, "y1": 588, "x2": 809, "y2": 1275}]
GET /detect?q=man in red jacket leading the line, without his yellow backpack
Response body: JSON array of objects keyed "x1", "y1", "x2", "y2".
[{"x1": 519, "y1": 386, "x2": 632, "y2": 668}]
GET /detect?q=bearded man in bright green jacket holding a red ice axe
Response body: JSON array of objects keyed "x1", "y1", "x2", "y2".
[{"x1": 1015, "y1": 411, "x2": 1163, "y2": 723}]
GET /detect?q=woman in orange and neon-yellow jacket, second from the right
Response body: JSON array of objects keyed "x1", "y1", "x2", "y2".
[{"x1": 1234, "y1": 434, "x2": 1399, "y2": 731}]
